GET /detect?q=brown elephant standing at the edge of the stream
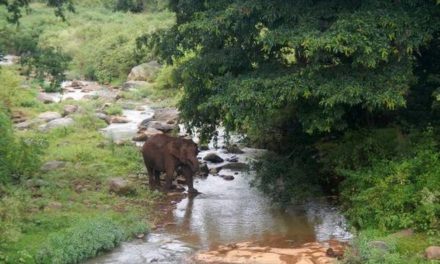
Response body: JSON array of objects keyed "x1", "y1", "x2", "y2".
[{"x1": 142, "y1": 134, "x2": 199, "y2": 194}]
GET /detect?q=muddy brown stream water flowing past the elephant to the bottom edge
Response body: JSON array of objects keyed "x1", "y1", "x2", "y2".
[{"x1": 88, "y1": 145, "x2": 352, "y2": 264}]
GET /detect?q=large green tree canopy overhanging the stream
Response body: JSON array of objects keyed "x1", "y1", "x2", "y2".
[{"x1": 144, "y1": 0, "x2": 440, "y2": 142}]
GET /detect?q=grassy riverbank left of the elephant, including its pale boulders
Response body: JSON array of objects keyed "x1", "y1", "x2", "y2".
[{"x1": 0, "y1": 64, "x2": 179, "y2": 263}]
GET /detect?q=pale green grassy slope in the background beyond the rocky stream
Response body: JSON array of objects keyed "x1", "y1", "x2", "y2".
[{"x1": 0, "y1": 2, "x2": 174, "y2": 84}]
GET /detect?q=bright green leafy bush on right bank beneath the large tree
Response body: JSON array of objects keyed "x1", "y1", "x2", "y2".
[{"x1": 342, "y1": 139, "x2": 440, "y2": 232}]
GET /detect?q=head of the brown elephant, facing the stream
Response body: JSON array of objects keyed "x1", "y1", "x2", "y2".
[{"x1": 171, "y1": 138, "x2": 199, "y2": 174}]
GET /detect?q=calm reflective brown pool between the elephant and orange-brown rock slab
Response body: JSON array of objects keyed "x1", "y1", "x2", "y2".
[{"x1": 162, "y1": 169, "x2": 350, "y2": 248}]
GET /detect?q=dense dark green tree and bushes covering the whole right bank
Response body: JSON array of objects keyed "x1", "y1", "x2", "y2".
[{"x1": 148, "y1": 0, "x2": 440, "y2": 236}]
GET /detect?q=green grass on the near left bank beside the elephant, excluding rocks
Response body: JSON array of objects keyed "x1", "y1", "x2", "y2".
[{"x1": 0, "y1": 68, "x2": 159, "y2": 263}]
